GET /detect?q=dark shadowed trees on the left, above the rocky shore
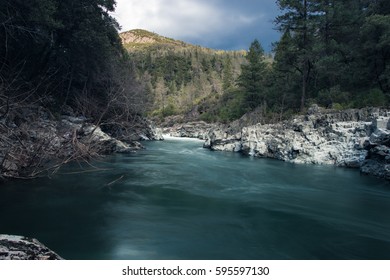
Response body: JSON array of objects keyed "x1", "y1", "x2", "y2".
[{"x1": 0, "y1": 0, "x2": 143, "y2": 126}]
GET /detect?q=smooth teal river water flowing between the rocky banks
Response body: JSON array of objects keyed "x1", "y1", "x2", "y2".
[{"x1": 0, "y1": 139, "x2": 390, "y2": 259}]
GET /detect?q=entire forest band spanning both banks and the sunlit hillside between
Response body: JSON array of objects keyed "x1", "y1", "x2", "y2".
[{"x1": 0, "y1": 0, "x2": 390, "y2": 126}]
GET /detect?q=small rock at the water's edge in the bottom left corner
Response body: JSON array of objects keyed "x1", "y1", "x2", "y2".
[{"x1": 0, "y1": 234, "x2": 62, "y2": 260}]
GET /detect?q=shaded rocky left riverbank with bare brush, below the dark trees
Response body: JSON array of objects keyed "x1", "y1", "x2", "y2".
[{"x1": 0, "y1": 107, "x2": 162, "y2": 180}]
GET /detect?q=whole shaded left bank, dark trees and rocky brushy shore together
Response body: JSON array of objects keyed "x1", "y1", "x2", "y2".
[{"x1": 0, "y1": 0, "x2": 147, "y2": 179}]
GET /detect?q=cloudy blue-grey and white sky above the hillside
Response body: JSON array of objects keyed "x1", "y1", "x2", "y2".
[{"x1": 114, "y1": 0, "x2": 279, "y2": 51}]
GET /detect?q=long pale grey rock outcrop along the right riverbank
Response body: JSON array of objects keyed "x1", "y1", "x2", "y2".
[{"x1": 204, "y1": 106, "x2": 390, "y2": 179}]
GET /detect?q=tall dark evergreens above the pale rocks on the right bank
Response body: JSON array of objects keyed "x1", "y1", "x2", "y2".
[{"x1": 269, "y1": 0, "x2": 390, "y2": 114}]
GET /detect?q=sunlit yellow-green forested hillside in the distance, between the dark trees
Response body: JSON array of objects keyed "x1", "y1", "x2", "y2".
[{"x1": 121, "y1": 30, "x2": 246, "y2": 120}]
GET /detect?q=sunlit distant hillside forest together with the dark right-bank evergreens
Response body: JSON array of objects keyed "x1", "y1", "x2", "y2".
[{"x1": 125, "y1": 0, "x2": 390, "y2": 122}]
